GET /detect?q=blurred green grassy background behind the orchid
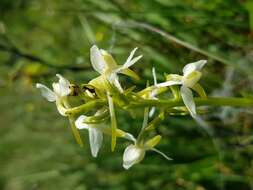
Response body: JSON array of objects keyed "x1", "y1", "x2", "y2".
[{"x1": 0, "y1": 0, "x2": 253, "y2": 190}]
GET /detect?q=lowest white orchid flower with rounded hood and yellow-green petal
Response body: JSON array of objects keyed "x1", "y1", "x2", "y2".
[{"x1": 123, "y1": 135, "x2": 172, "y2": 169}]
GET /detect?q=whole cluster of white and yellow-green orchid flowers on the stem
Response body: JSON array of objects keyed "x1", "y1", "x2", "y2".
[{"x1": 36, "y1": 45, "x2": 207, "y2": 169}]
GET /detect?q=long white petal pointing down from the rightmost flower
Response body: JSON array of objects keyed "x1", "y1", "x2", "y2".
[{"x1": 180, "y1": 85, "x2": 196, "y2": 117}]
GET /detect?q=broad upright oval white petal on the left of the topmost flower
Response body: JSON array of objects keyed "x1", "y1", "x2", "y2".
[{"x1": 90, "y1": 45, "x2": 106, "y2": 74}]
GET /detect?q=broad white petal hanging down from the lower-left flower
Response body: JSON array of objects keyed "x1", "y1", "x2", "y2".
[{"x1": 89, "y1": 127, "x2": 103, "y2": 157}]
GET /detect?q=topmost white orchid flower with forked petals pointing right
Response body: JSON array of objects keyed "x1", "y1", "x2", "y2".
[{"x1": 90, "y1": 45, "x2": 142, "y2": 92}]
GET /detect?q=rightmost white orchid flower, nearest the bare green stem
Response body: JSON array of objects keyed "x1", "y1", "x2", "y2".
[{"x1": 156, "y1": 60, "x2": 207, "y2": 118}]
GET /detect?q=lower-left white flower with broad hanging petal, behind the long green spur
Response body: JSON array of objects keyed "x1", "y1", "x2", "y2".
[{"x1": 75, "y1": 111, "x2": 135, "y2": 157}]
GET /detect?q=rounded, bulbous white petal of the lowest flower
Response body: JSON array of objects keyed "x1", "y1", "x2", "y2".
[{"x1": 123, "y1": 145, "x2": 145, "y2": 169}]
